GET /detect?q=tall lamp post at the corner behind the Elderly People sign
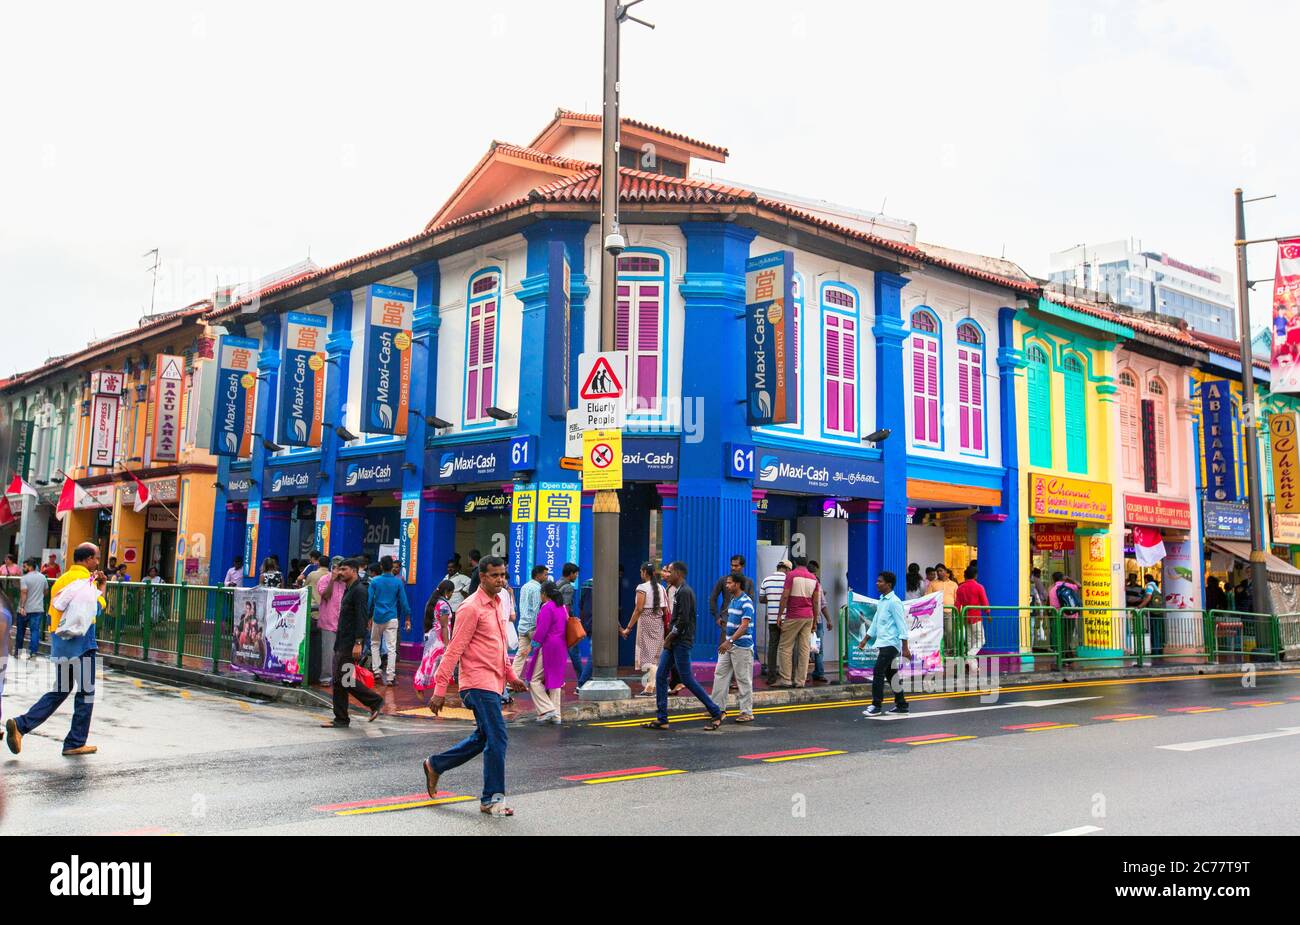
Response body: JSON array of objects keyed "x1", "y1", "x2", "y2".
[{"x1": 579, "y1": 0, "x2": 654, "y2": 700}]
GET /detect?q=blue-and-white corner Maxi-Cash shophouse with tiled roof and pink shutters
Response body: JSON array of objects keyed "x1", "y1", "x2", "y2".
[{"x1": 202, "y1": 110, "x2": 1036, "y2": 660}]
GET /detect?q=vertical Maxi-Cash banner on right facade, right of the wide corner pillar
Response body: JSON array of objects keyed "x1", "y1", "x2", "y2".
[{"x1": 745, "y1": 251, "x2": 798, "y2": 426}]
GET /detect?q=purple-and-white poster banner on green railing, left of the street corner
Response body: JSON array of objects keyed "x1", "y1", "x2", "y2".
[{"x1": 230, "y1": 587, "x2": 309, "y2": 683}]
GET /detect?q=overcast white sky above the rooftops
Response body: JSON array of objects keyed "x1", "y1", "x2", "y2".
[{"x1": 0, "y1": 0, "x2": 1300, "y2": 375}]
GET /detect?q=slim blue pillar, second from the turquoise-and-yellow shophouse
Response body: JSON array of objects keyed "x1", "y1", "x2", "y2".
[{"x1": 871, "y1": 272, "x2": 909, "y2": 585}]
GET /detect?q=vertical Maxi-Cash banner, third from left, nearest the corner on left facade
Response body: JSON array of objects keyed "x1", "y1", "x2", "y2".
[{"x1": 361, "y1": 285, "x2": 415, "y2": 437}]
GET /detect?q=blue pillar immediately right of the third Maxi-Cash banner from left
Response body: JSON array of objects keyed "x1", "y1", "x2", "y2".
[{"x1": 398, "y1": 261, "x2": 450, "y2": 620}]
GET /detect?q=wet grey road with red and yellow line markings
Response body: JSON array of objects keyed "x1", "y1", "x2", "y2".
[{"x1": 0, "y1": 649, "x2": 1300, "y2": 837}]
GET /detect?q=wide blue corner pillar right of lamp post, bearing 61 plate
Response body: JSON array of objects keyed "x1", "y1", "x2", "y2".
[{"x1": 676, "y1": 222, "x2": 758, "y2": 661}]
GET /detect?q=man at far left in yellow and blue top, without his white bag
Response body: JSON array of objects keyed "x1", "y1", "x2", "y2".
[{"x1": 4, "y1": 543, "x2": 108, "y2": 757}]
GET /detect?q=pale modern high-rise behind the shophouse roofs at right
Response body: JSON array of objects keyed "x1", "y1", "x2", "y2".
[{"x1": 1050, "y1": 240, "x2": 1236, "y2": 338}]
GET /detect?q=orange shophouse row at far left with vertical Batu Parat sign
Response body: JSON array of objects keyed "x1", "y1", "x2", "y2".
[{"x1": 3, "y1": 301, "x2": 216, "y2": 583}]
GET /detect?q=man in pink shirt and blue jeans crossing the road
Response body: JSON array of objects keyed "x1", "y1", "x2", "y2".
[{"x1": 424, "y1": 556, "x2": 524, "y2": 816}]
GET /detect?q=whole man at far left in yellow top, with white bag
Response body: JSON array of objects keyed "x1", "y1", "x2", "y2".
[{"x1": 4, "y1": 543, "x2": 108, "y2": 757}]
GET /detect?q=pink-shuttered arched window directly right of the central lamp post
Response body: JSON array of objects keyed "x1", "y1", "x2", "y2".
[{"x1": 614, "y1": 251, "x2": 668, "y2": 413}]
